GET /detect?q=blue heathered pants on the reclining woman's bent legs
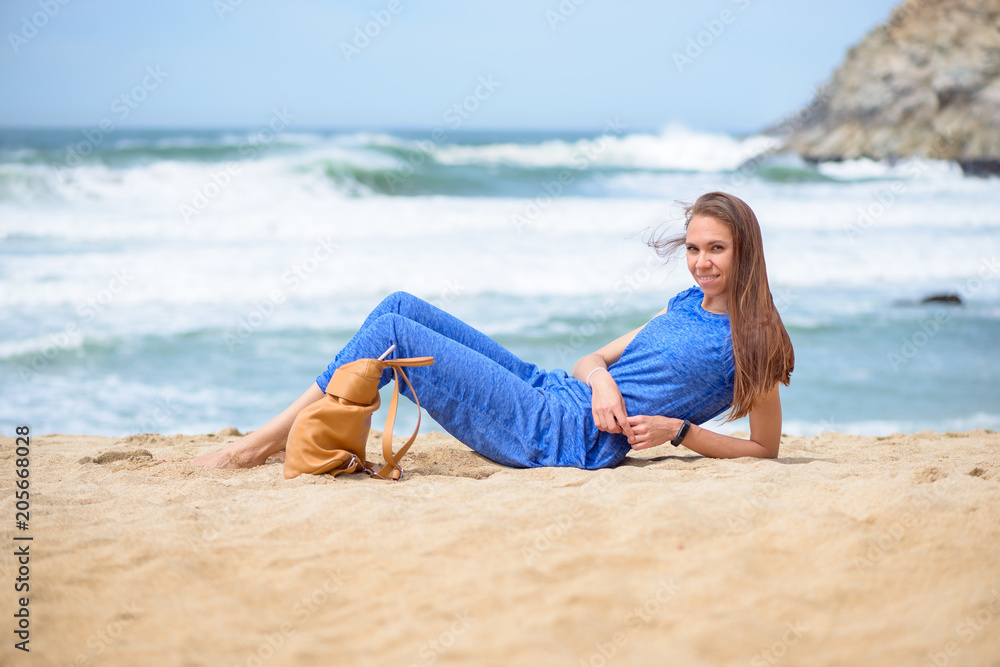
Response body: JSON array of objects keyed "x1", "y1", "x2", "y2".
[{"x1": 316, "y1": 292, "x2": 628, "y2": 469}]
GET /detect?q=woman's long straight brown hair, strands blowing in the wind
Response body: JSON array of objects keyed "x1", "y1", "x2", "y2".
[{"x1": 646, "y1": 192, "x2": 795, "y2": 422}]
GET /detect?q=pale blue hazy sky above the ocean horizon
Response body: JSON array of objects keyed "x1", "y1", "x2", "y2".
[{"x1": 0, "y1": 0, "x2": 897, "y2": 133}]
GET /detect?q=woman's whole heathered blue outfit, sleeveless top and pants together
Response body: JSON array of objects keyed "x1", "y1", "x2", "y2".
[{"x1": 316, "y1": 287, "x2": 735, "y2": 469}]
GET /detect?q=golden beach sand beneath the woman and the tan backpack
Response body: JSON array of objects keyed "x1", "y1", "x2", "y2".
[{"x1": 0, "y1": 429, "x2": 1000, "y2": 667}]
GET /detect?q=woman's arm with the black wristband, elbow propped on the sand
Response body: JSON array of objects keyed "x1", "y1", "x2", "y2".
[{"x1": 628, "y1": 383, "x2": 781, "y2": 459}]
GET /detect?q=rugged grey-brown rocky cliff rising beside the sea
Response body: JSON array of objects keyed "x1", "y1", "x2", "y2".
[{"x1": 785, "y1": 0, "x2": 1000, "y2": 175}]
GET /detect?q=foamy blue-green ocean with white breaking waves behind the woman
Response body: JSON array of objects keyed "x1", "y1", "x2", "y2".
[{"x1": 0, "y1": 124, "x2": 1000, "y2": 436}]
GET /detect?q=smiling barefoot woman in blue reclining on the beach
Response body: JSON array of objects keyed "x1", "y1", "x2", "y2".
[{"x1": 189, "y1": 192, "x2": 794, "y2": 469}]
